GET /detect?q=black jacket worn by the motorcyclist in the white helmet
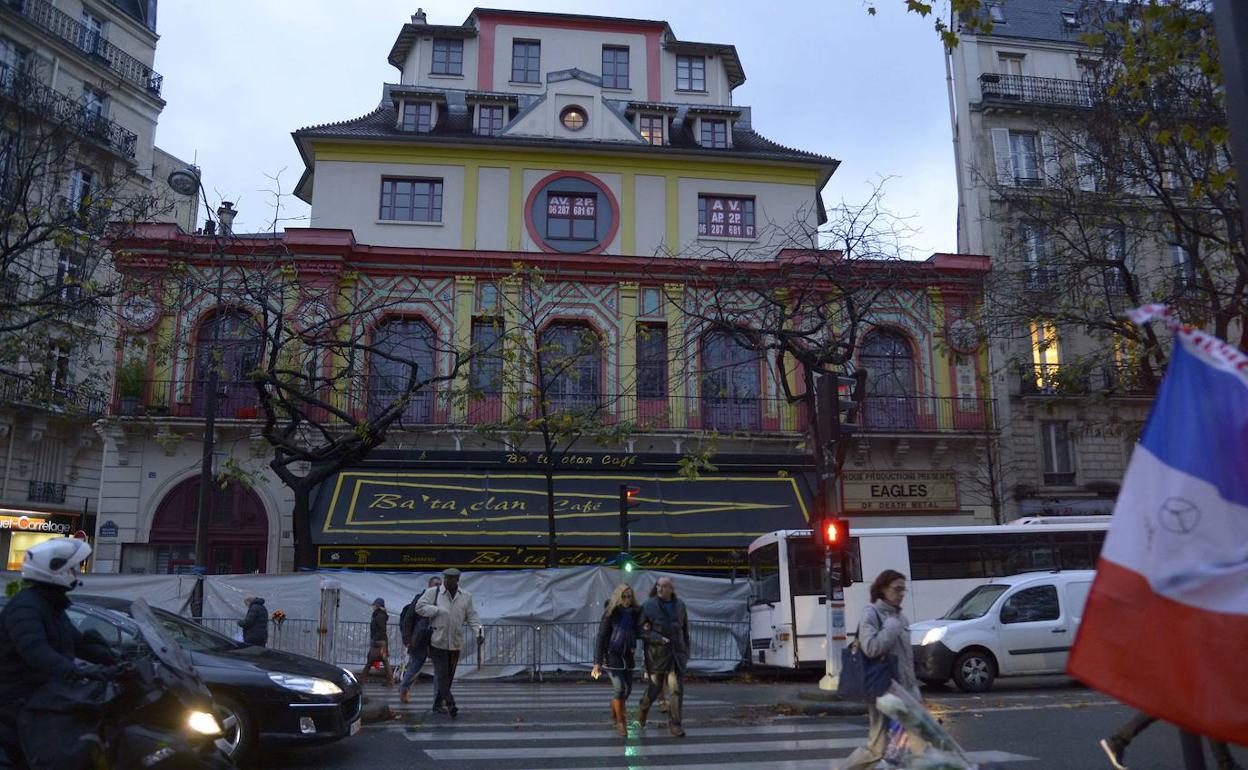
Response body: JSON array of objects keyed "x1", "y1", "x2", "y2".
[{"x1": 0, "y1": 583, "x2": 116, "y2": 704}]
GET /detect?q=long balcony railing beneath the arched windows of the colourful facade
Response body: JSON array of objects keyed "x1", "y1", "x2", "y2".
[{"x1": 112, "y1": 379, "x2": 996, "y2": 434}]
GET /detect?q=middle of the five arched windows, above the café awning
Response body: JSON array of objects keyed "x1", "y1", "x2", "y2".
[{"x1": 538, "y1": 323, "x2": 603, "y2": 411}]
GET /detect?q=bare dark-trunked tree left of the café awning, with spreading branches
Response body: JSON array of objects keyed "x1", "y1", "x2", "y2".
[{"x1": 148, "y1": 222, "x2": 470, "y2": 565}]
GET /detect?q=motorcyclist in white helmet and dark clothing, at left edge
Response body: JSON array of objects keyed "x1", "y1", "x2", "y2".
[{"x1": 0, "y1": 538, "x2": 116, "y2": 768}]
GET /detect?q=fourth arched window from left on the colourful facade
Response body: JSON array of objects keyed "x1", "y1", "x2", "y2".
[{"x1": 701, "y1": 332, "x2": 763, "y2": 431}]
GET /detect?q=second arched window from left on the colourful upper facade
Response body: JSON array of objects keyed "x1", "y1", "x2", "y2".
[{"x1": 368, "y1": 318, "x2": 437, "y2": 423}]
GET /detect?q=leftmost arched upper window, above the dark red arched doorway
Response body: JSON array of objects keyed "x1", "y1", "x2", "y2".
[{"x1": 191, "y1": 309, "x2": 265, "y2": 417}]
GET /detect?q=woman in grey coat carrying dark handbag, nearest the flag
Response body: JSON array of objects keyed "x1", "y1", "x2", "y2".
[{"x1": 841, "y1": 569, "x2": 925, "y2": 770}]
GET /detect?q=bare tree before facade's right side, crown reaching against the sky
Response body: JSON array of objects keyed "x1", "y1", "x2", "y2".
[{"x1": 681, "y1": 182, "x2": 910, "y2": 514}]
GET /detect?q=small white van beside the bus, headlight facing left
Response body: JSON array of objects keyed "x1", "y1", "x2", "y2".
[{"x1": 910, "y1": 570, "x2": 1096, "y2": 693}]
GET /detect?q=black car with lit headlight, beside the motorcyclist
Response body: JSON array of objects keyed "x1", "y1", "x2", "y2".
[{"x1": 69, "y1": 595, "x2": 362, "y2": 763}]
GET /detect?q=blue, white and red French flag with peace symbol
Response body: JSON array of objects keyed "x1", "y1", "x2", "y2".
[{"x1": 1067, "y1": 306, "x2": 1248, "y2": 744}]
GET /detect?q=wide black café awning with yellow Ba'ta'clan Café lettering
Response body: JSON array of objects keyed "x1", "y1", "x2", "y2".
[{"x1": 312, "y1": 452, "x2": 811, "y2": 574}]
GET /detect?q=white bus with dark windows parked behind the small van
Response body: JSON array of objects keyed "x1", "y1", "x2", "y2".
[{"x1": 749, "y1": 515, "x2": 1109, "y2": 668}]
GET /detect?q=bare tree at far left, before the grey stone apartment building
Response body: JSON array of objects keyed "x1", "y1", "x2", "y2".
[{"x1": 0, "y1": 56, "x2": 170, "y2": 401}]
